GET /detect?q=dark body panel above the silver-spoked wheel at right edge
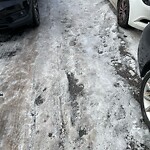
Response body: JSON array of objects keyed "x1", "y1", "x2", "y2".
[{"x1": 138, "y1": 24, "x2": 150, "y2": 77}]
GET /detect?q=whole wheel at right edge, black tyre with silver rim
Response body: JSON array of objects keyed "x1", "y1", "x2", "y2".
[{"x1": 140, "y1": 71, "x2": 150, "y2": 129}]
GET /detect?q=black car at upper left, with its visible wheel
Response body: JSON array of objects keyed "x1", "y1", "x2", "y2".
[{"x1": 0, "y1": 0, "x2": 40, "y2": 29}]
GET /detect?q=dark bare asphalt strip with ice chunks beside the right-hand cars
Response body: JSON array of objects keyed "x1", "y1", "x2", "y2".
[{"x1": 111, "y1": 27, "x2": 141, "y2": 101}]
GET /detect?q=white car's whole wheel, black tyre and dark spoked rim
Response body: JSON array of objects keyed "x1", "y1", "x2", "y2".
[{"x1": 117, "y1": 0, "x2": 129, "y2": 28}]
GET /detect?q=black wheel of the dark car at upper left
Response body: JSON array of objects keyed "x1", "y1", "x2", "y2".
[{"x1": 32, "y1": 0, "x2": 40, "y2": 27}]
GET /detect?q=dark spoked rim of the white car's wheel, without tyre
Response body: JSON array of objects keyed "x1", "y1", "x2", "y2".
[{"x1": 119, "y1": 0, "x2": 127, "y2": 22}]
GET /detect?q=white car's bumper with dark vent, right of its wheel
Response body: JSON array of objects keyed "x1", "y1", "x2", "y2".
[{"x1": 128, "y1": 0, "x2": 150, "y2": 30}]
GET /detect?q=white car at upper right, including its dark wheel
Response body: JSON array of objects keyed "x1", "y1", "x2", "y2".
[{"x1": 109, "y1": 0, "x2": 150, "y2": 30}]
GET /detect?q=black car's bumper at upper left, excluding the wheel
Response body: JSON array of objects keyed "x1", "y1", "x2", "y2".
[{"x1": 0, "y1": 0, "x2": 32, "y2": 30}]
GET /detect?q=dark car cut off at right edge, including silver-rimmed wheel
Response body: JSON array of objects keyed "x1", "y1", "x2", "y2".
[{"x1": 138, "y1": 24, "x2": 150, "y2": 129}]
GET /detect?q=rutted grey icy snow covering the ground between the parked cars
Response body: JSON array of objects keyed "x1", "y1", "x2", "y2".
[{"x1": 0, "y1": 0, "x2": 150, "y2": 150}]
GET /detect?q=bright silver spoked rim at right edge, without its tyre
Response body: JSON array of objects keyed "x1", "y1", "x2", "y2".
[{"x1": 143, "y1": 79, "x2": 150, "y2": 120}]
